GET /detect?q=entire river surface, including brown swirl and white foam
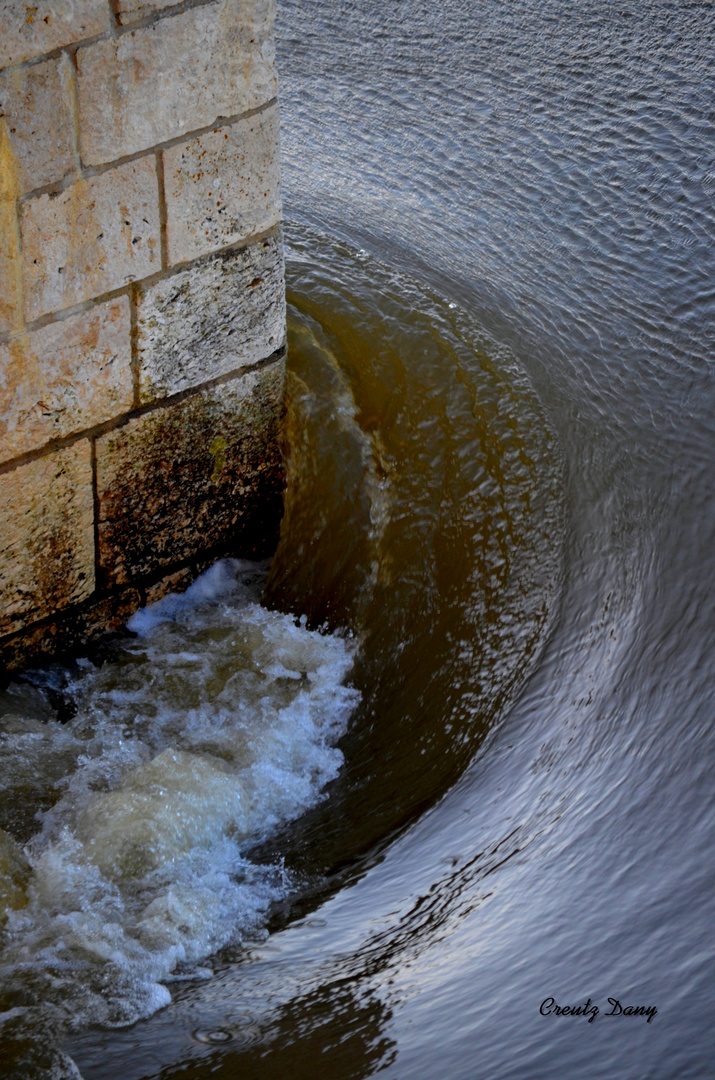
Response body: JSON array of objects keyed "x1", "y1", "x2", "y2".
[{"x1": 0, "y1": 0, "x2": 715, "y2": 1080}]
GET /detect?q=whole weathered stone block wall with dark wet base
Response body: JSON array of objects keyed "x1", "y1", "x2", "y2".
[{"x1": 0, "y1": 0, "x2": 285, "y2": 667}]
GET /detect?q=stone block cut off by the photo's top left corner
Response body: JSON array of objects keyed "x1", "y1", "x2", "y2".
[{"x1": 0, "y1": 0, "x2": 110, "y2": 68}]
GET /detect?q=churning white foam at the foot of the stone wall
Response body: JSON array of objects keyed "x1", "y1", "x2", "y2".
[{"x1": 0, "y1": 561, "x2": 358, "y2": 1024}]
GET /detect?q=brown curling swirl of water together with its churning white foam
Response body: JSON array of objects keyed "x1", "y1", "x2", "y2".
[{"x1": 0, "y1": 228, "x2": 563, "y2": 1068}]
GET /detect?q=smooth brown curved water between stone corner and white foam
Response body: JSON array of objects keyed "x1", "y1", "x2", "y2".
[{"x1": 259, "y1": 232, "x2": 562, "y2": 872}]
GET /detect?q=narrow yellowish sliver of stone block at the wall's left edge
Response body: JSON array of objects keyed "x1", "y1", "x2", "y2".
[{"x1": 0, "y1": 117, "x2": 23, "y2": 334}]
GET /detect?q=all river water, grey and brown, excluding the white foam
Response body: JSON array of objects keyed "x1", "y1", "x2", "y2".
[{"x1": 5, "y1": 0, "x2": 715, "y2": 1080}]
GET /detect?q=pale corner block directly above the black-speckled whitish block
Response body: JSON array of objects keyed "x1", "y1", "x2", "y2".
[{"x1": 164, "y1": 106, "x2": 281, "y2": 265}]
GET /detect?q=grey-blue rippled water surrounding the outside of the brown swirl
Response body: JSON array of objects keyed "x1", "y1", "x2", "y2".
[{"x1": 1, "y1": 0, "x2": 715, "y2": 1080}]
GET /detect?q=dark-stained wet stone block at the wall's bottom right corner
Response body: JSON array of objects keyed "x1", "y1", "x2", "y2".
[{"x1": 97, "y1": 362, "x2": 284, "y2": 583}]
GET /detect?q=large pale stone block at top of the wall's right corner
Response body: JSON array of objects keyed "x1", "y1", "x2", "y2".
[{"x1": 77, "y1": 0, "x2": 275, "y2": 165}]
